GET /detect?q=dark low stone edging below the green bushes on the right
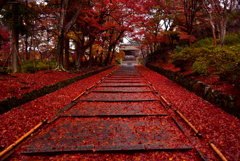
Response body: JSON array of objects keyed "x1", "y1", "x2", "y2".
[{"x1": 146, "y1": 64, "x2": 240, "y2": 118}]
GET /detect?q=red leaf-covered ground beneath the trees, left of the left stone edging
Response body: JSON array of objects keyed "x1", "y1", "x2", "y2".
[{"x1": 0, "y1": 67, "x2": 105, "y2": 100}]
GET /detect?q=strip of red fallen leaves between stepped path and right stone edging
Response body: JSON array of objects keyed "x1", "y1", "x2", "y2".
[{"x1": 138, "y1": 66, "x2": 240, "y2": 160}]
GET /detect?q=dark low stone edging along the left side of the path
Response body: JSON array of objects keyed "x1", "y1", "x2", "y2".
[{"x1": 0, "y1": 65, "x2": 114, "y2": 114}]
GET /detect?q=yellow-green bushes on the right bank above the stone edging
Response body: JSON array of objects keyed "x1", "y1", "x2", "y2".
[{"x1": 170, "y1": 39, "x2": 240, "y2": 85}]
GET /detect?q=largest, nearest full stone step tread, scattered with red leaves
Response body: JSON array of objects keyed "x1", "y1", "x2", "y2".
[{"x1": 22, "y1": 116, "x2": 192, "y2": 154}]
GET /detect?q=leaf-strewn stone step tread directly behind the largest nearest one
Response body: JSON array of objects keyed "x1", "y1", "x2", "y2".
[{"x1": 64, "y1": 101, "x2": 168, "y2": 117}]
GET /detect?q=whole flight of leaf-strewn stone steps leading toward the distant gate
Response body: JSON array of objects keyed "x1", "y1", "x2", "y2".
[{"x1": 23, "y1": 66, "x2": 192, "y2": 154}]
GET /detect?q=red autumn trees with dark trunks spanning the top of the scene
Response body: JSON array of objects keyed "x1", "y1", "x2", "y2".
[{"x1": 0, "y1": 0, "x2": 239, "y2": 72}]
